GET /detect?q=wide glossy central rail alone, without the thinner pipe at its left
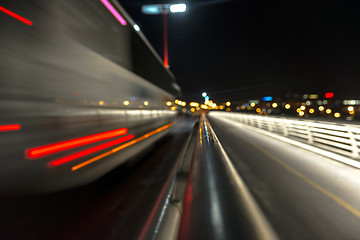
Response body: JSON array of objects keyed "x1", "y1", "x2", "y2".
[{"x1": 178, "y1": 115, "x2": 277, "y2": 240}]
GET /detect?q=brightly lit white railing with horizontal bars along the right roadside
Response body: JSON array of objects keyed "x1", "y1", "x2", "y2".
[{"x1": 209, "y1": 111, "x2": 360, "y2": 160}]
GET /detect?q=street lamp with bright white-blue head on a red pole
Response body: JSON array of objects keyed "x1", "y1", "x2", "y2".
[{"x1": 141, "y1": 3, "x2": 187, "y2": 68}]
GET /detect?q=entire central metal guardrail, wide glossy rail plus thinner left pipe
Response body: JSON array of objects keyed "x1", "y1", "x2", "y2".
[{"x1": 138, "y1": 115, "x2": 278, "y2": 240}]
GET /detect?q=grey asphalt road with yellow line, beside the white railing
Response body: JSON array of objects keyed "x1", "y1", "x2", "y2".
[{"x1": 210, "y1": 117, "x2": 360, "y2": 240}]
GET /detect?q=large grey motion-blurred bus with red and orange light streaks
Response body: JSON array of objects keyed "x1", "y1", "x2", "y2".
[{"x1": 0, "y1": 0, "x2": 180, "y2": 194}]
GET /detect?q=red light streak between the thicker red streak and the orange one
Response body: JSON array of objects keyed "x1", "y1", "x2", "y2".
[{"x1": 50, "y1": 135, "x2": 134, "y2": 166}]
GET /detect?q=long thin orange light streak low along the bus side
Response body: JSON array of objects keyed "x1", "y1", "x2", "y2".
[{"x1": 71, "y1": 123, "x2": 173, "y2": 171}]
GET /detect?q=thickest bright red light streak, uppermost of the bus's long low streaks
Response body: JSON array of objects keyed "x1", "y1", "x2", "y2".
[{"x1": 26, "y1": 128, "x2": 127, "y2": 159}]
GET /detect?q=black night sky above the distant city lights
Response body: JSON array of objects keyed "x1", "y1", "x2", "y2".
[{"x1": 120, "y1": 0, "x2": 360, "y2": 101}]
